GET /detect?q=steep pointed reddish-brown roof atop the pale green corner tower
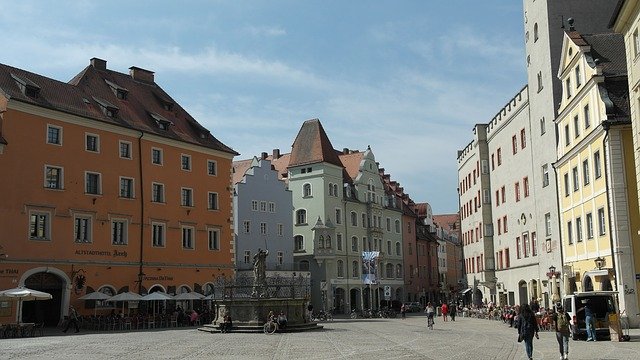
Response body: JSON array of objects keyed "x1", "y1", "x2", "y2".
[{"x1": 289, "y1": 119, "x2": 342, "y2": 167}]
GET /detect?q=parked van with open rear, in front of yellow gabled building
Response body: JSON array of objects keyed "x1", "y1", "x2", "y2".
[{"x1": 562, "y1": 291, "x2": 618, "y2": 340}]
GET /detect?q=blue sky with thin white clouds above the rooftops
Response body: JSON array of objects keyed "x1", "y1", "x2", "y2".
[{"x1": 0, "y1": 0, "x2": 526, "y2": 214}]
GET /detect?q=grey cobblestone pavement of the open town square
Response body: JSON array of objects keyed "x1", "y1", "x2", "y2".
[{"x1": 0, "y1": 315, "x2": 640, "y2": 360}]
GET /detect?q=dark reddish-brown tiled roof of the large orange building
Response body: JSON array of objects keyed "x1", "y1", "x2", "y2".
[{"x1": 0, "y1": 60, "x2": 238, "y2": 155}]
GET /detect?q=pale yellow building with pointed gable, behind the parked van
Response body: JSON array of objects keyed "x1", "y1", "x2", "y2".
[{"x1": 555, "y1": 24, "x2": 638, "y2": 324}]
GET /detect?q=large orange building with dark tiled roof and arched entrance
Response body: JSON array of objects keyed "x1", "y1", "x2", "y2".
[{"x1": 0, "y1": 58, "x2": 237, "y2": 325}]
